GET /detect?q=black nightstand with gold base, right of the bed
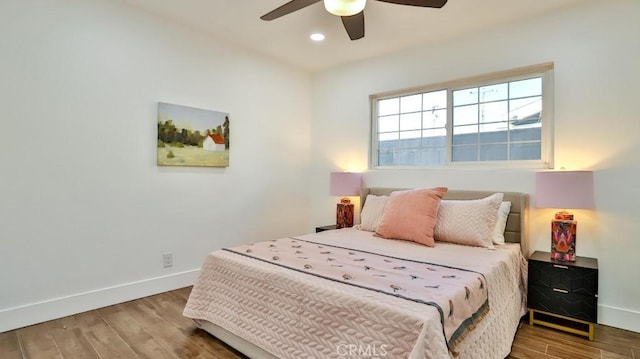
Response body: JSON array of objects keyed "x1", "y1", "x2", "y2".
[{"x1": 528, "y1": 251, "x2": 598, "y2": 340}]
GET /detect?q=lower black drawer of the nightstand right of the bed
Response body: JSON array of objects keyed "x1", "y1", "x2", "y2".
[{"x1": 528, "y1": 283, "x2": 598, "y2": 323}]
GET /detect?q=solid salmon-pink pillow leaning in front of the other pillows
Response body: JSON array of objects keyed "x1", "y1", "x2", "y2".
[{"x1": 376, "y1": 187, "x2": 447, "y2": 247}]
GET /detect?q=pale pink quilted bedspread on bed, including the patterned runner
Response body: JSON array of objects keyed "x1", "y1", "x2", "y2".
[{"x1": 184, "y1": 231, "x2": 520, "y2": 358}]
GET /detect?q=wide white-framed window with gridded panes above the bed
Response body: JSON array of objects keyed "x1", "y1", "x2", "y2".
[{"x1": 371, "y1": 64, "x2": 553, "y2": 168}]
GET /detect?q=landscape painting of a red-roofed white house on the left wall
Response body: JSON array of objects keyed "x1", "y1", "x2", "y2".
[{"x1": 158, "y1": 102, "x2": 229, "y2": 167}]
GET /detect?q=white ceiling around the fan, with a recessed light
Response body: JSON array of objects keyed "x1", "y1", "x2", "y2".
[{"x1": 118, "y1": 0, "x2": 586, "y2": 72}]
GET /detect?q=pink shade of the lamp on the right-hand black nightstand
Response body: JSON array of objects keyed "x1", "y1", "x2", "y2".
[{"x1": 536, "y1": 171, "x2": 595, "y2": 209}]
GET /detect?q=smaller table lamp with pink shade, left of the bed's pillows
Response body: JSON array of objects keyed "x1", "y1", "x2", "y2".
[{"x1": 329, "y1": 172, "x2": 362, "y2": 228}]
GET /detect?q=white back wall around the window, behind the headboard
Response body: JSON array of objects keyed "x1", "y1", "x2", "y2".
[{"x1": 311, "y1": 0, "x2": 640, "y2": 332}]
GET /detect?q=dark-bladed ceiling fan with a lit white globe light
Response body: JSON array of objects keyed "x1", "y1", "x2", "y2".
[{"x1": 260, "y1": 0, "x2": 447, "y2": 40}]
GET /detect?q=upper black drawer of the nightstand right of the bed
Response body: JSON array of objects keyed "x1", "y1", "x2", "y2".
[{"x1": 529, "y1": 260, "x2": 598, "y2": 296}]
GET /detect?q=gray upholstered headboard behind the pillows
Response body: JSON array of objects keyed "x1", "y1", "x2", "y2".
[{"x1": 360, "y1": 187, "x2": 529, "y2": 256}]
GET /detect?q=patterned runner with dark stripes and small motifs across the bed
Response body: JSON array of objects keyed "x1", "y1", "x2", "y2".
[{"x1": 225, "y1": 238, "x2": 489, "y2": 347}]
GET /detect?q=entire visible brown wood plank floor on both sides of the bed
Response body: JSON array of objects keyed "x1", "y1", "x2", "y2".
[{"x1": 0, "y1": 288, "x2": 640, "y2": 359}]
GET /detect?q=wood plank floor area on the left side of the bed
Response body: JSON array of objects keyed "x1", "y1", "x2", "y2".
[{"x1": 0, "y1": 287, "x2": 244, "y2": 359}]
